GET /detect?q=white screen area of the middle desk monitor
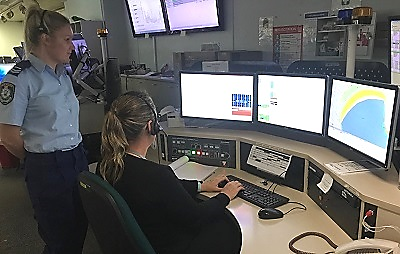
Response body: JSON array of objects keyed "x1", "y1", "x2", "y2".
[{"x1": 257, "y1": 74, "x2": 325, "y2": 134}]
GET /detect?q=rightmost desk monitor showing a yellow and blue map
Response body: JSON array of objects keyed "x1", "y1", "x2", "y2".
[{"x1": 327, "y1": 77, "x2": 398, "y2": 168}]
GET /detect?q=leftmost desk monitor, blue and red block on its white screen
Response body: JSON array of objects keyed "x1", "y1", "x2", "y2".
[{"x1": 180, "y1": 72, "x2": 254, "y2": 122}]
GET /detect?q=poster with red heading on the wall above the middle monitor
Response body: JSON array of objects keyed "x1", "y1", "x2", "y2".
[{"x1": 273, "y1": 25, "x2": 303, "y2": 70}]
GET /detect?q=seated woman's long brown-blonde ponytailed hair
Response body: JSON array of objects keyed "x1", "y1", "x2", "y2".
[{"x1": 100, "y1": 92, "x2": 155, "y2": 185}]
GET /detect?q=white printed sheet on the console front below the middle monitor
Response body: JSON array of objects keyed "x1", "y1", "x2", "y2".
[{"x1": 247, "y1": 145, "x2": 292, "y2": 178}]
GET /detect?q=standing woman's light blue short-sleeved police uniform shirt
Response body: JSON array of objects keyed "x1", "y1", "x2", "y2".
[{"x1": 0, "y1": 55, "x2": 82, "y2": 153}]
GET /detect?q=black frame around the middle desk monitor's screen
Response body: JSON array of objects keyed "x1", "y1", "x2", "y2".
[{"x1": 254, "y1": 72, "x2": 329, "y2": 137}]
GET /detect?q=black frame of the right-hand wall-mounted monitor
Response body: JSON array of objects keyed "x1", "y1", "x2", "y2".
[{"x1": 163, "y1": 0, "x2": 225, "y2": 34}]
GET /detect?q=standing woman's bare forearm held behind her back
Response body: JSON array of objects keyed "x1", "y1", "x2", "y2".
[{"x1": 0, "y1": 124, "x2": 25, "y2": 159}]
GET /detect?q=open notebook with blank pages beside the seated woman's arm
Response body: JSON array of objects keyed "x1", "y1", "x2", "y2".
[{"x1": 169, "y1": 156, "x2": 218, "y2": 181}]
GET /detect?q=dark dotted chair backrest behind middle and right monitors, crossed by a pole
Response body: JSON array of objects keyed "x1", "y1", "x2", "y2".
[{"x1": 287, "y1": 60, "x2": 390, "y2": 83}]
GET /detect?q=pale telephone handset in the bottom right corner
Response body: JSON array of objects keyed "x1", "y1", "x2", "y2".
[{"x1": 335, "y1": 239, "x2": 400, "y2": 254}]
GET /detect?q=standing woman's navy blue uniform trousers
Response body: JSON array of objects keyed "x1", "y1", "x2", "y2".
[{"x1": 25, "y1": 144, "x2": 88, "y2": 254}]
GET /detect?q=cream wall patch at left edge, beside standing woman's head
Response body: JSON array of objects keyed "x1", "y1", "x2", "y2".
[{"x1": 0, "y1": 22, "x2": 24, "y2": 56}]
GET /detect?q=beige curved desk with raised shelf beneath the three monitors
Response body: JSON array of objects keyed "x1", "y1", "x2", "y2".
[{"x1": 160, "y1": 128, "x2": 400, "y2": 247}]
